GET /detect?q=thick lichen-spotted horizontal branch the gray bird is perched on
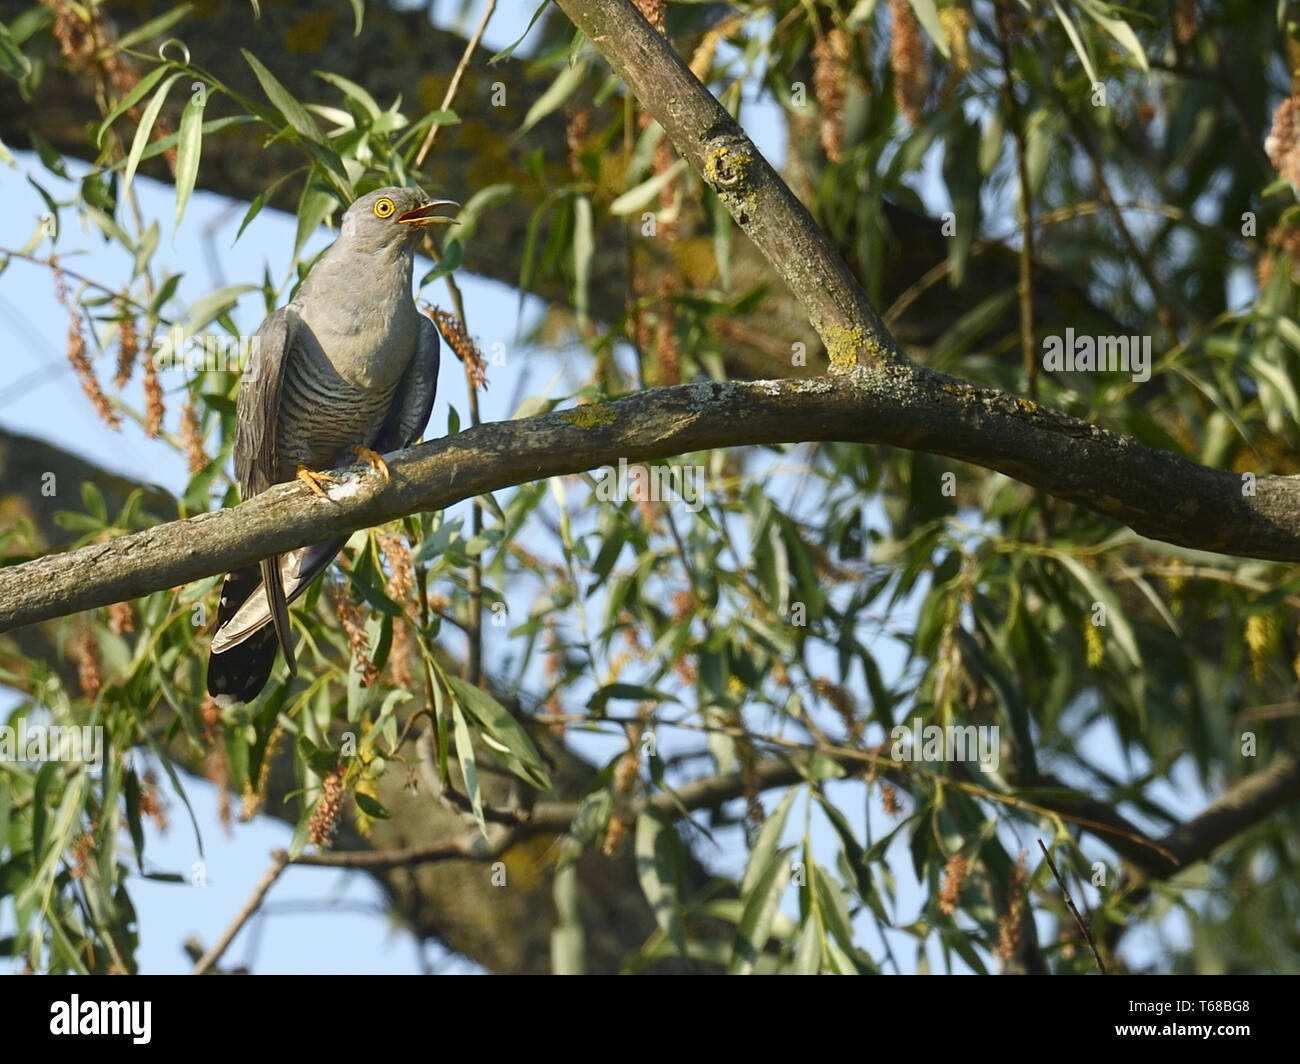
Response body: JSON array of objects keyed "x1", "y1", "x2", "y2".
[{"x1": 0, "y1": 364, "x2": 1300, "y2": 631}]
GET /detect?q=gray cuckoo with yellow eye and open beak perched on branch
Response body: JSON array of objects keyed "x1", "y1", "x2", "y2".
[{"x1": 208, "y1": 189, "x2": 458, "y2": 702}]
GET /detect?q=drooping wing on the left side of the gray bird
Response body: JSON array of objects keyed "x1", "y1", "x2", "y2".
[{"x1": 232, "y1": 303, "x2": 302, "y2": 675}]
